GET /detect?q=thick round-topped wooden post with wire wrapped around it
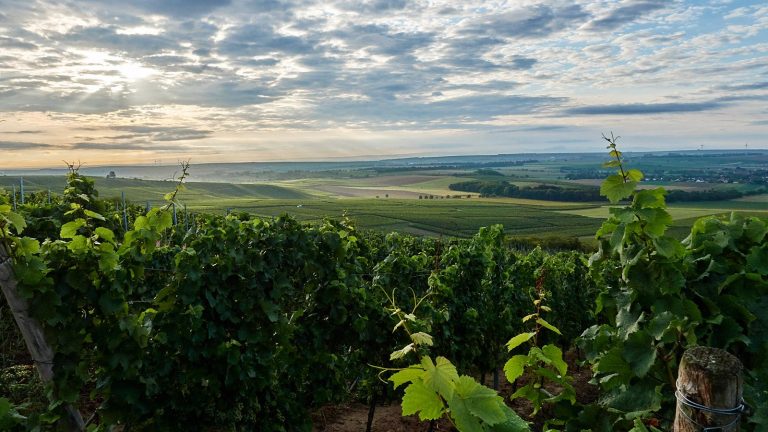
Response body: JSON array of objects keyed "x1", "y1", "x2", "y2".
[{"x1": 672, "y1": 347, "x2": 746, "y2": 432}]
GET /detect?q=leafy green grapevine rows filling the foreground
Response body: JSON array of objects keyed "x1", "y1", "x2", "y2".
[{"x1": 0, "y1": 147, "x2": 768, "y2": 432}]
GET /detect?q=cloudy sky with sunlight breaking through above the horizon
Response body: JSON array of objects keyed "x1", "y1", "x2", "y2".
[{"x1": 0, "y1": 0, "x2": 768, "y2": 169}]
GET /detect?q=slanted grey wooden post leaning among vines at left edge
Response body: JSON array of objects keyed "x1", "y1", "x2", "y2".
[{"x1": 0, "y1": 240, "x2": 85, "y2": 431}]
